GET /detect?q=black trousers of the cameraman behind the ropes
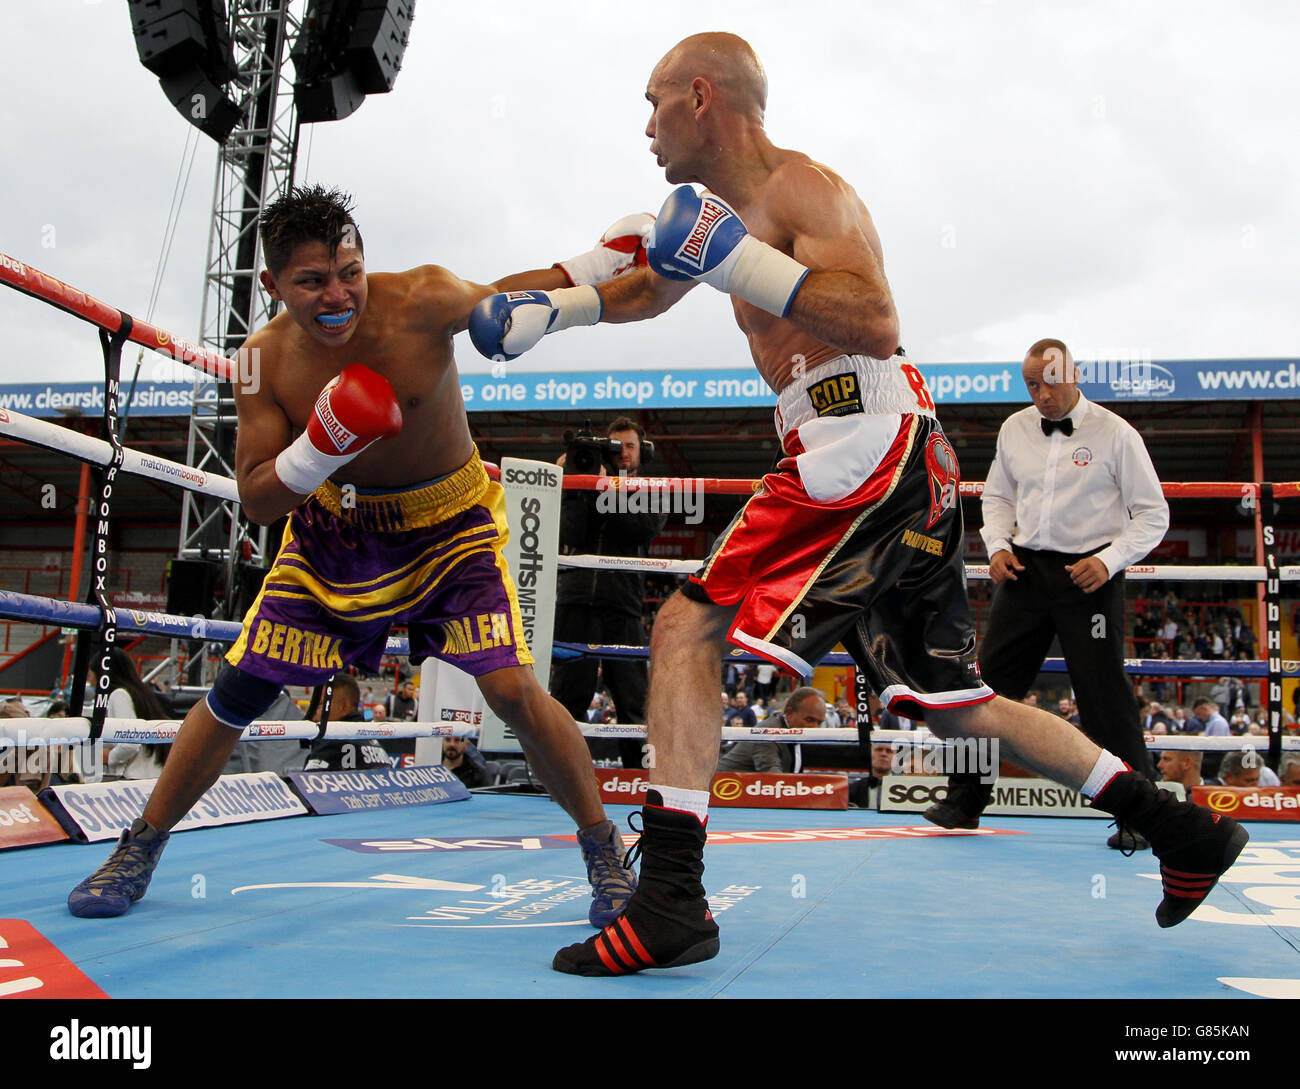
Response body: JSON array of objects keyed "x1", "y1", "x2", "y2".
[{"x1": 551, "y1": 606, "x2": 649, "y2": 768}]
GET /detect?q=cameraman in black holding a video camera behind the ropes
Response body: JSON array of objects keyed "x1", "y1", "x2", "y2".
[{"x1": 551, "y1": 416, "x2": 668, "y2": 768}]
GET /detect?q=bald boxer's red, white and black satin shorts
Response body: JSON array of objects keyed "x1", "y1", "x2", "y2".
[{"x1": 683, "y1": 356, "x2": 993, "y2": 719}]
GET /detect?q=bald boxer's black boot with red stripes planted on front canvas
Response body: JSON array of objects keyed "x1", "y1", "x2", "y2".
[{"x1": 551, "y1": 789, "x2": 719, "y2": 976}]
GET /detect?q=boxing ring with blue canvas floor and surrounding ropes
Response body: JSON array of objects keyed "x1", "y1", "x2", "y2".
[{"x1": 0, "y1": 255, "x2": 1300, "y2": 1057}]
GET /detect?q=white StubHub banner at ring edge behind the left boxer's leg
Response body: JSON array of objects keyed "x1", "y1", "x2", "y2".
[{"x1": 38, "y1": 772, "x2": 307, "y2": 843}]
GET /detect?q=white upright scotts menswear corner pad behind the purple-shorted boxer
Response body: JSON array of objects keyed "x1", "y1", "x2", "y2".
[{"x1": 416, "y1": 457, "x2": 564, "y2": 763}]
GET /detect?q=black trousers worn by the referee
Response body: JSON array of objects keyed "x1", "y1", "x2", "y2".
[{"x1": 979, "y1": 548, "x2": 1156, "y2": 778}]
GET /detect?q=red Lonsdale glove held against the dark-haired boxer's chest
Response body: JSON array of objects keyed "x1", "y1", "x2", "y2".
[{"x1": 276, "y1": 363, "x2": 402, "y2": 495}]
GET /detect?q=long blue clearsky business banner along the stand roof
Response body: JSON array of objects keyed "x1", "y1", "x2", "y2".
[{"x1": 0, "y1": 355, "x2": 1300, "y2": 422}]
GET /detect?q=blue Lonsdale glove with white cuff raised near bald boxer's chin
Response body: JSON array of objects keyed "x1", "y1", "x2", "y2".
[{"x1": 646, "y1": 186, "x2": 809, "y2": 317}]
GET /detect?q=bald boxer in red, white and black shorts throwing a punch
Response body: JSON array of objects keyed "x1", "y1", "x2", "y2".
[{"x1": 471, "y1": 34, "x2": 1247, "y2": 976}]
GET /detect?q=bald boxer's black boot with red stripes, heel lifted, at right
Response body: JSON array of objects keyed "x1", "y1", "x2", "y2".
[{"x1": 1092, "y1": 772, "x2": 1251, "y2": 927}]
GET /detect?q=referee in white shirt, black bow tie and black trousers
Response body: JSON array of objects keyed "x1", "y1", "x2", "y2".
[{"x1": 926, "y1": 339, "x2": 1169, "y2": 849}]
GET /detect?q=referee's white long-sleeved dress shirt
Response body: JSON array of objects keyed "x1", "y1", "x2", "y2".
[{"x1": 980, "y1": 392, "x2": 1169, "y2": 576}]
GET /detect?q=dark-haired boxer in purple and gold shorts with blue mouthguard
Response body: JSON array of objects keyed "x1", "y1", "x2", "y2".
[{"x1": 68, "y1": 187, "x2": 649, "y2": 925}]
